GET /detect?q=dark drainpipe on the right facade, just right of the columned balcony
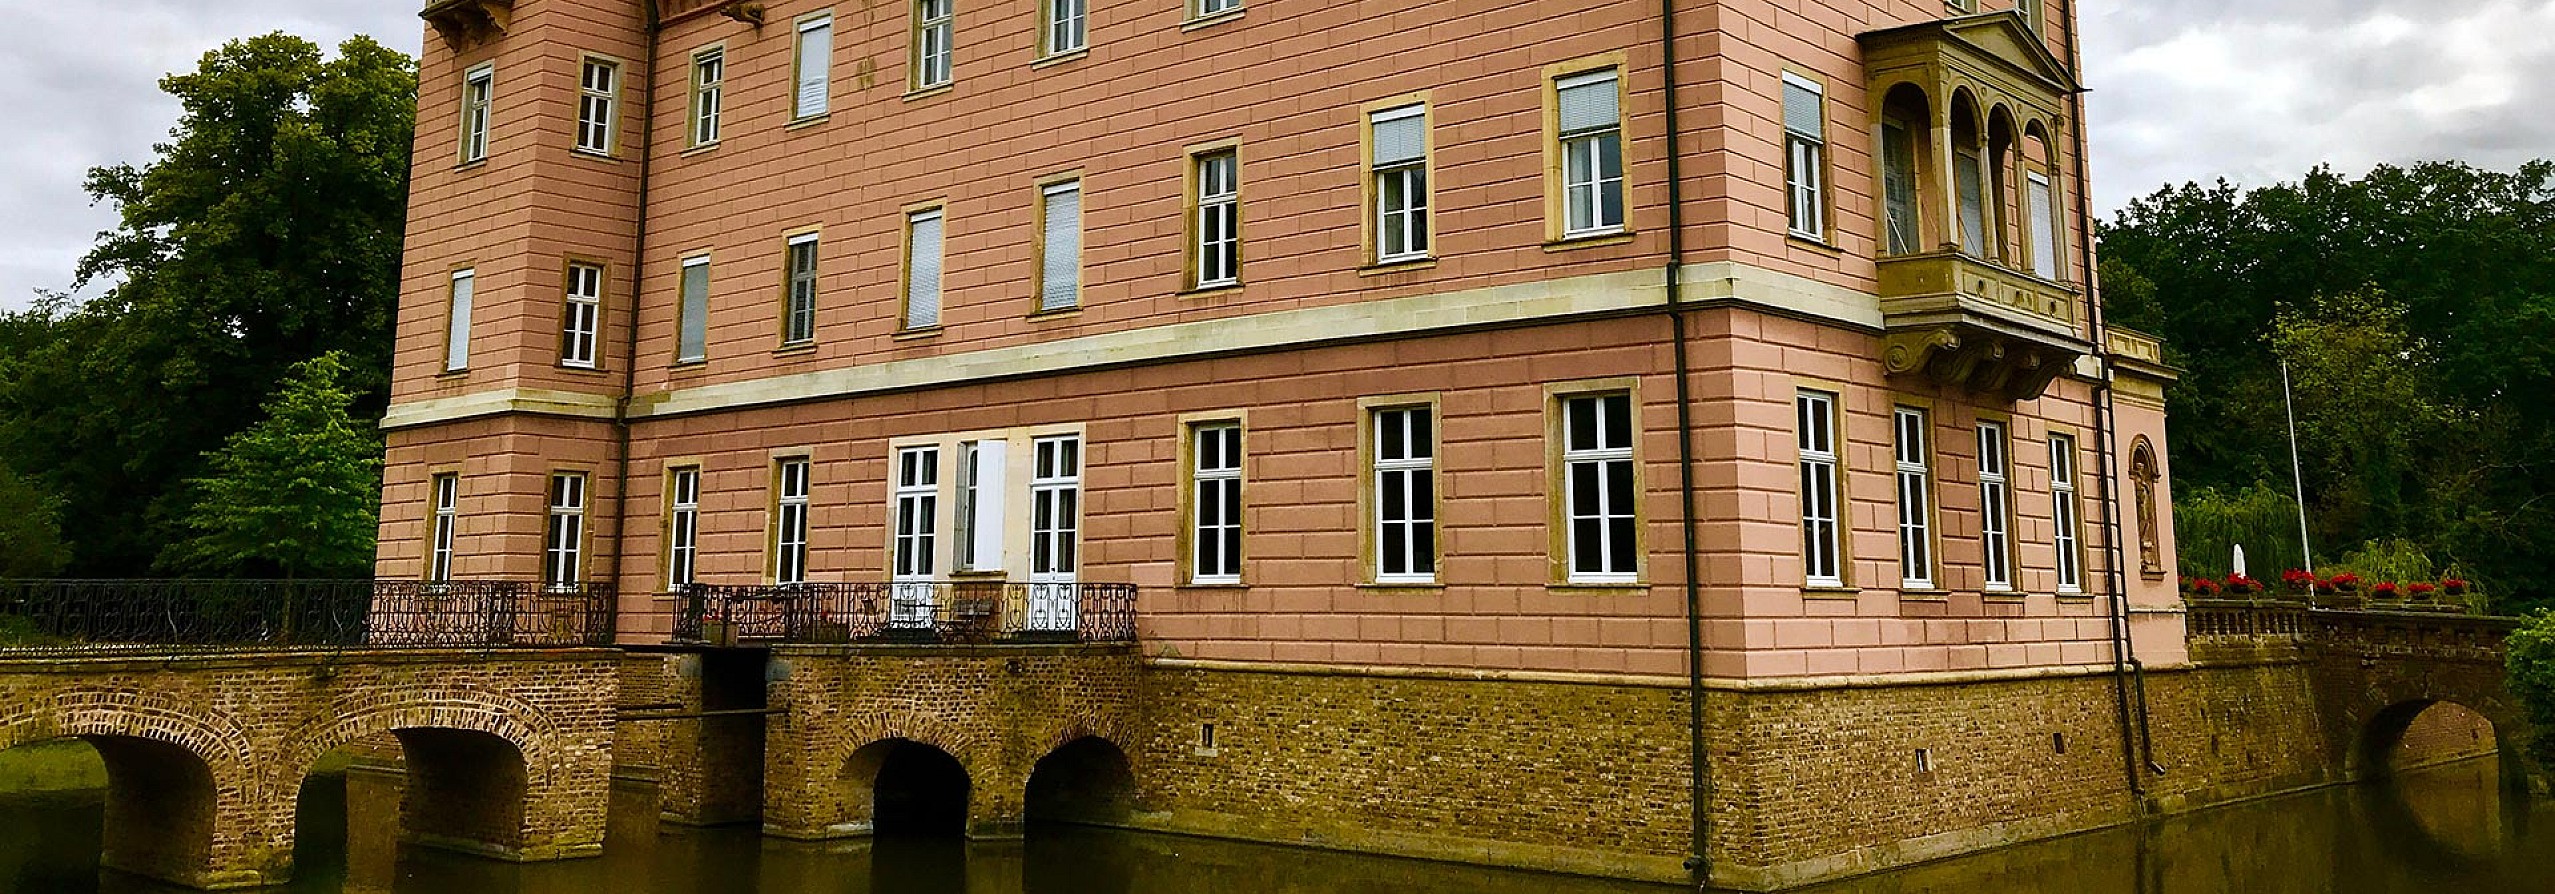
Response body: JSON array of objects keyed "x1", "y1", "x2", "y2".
[{"x1": 2059, "y1": 3, "x2": 2164, "y2": 805}]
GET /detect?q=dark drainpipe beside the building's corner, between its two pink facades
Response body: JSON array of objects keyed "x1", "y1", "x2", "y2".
[{"x1": 1658, "y1": 0, "x2": 1712, "y2": 889}]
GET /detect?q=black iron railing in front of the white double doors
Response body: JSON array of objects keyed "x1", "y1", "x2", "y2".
[{"x1": 675, "y1": 580, "x2": 1134, "y2": 646}]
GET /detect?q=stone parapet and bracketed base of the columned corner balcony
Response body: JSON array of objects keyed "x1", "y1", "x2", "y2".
[{"x1": 1880, "y1": 250, "x2": 2093, "y2": 401}]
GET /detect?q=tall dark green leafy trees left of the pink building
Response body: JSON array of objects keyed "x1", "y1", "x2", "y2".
[{"x1": 0, "y1": 33, "x2": 416, "y2": 577}]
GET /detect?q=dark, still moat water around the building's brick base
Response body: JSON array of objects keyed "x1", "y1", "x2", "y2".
[{"x1": 0, "y1": 761, "x2": 2555, "y2": 894}]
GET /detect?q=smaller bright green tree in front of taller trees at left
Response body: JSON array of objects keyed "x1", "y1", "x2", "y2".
[{"x1": 161, "y1": 352, "x2": 381, "y2": 577}]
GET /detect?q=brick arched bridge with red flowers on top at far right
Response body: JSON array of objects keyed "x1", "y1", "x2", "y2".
[{"x1": 2187, "y1": 600, "x2": 2555, "y2": 794}]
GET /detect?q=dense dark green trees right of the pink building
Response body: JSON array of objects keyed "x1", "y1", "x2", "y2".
[{"x1": 2100, "y1": 161, "x2": 2555, "y2": 608}]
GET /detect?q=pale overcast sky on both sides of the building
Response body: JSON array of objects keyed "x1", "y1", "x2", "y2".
[{"x1": 0, "y1": 0, "x2": 2555, "y2": 307}]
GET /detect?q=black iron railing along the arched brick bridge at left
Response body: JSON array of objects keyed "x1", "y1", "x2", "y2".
[{"x1": 0, "y1": 580, "x2": 613, "y2": 651}]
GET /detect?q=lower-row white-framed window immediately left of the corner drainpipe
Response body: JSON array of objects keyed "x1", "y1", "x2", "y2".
[{"x1": 1561, "y1": 393, "x2": 1640, "y2": 582}]
